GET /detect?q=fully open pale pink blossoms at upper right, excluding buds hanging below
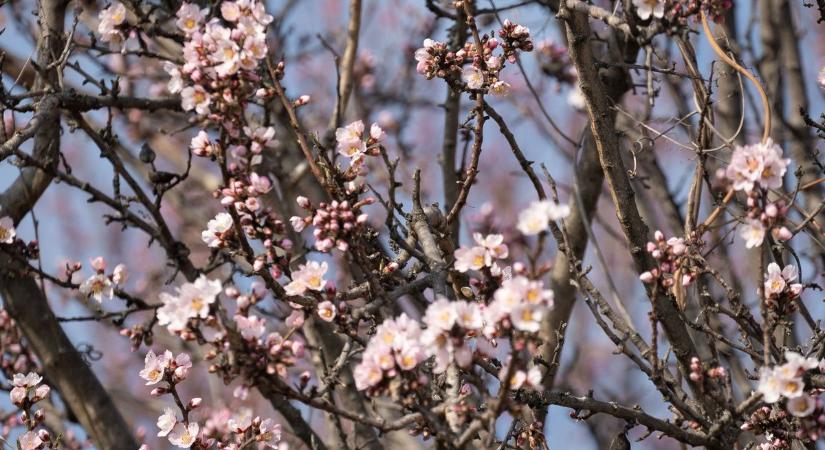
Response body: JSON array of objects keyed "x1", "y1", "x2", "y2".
[{"x1": 725, "y1": 139, "x2": 790, "y2": 192}]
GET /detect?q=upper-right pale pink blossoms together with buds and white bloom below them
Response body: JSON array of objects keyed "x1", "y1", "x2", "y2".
[{"x1": 724, "y1": 139, "x2": 792, "y2": 248}]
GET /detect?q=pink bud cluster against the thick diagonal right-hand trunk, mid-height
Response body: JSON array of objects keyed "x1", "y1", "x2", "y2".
[{"x1": 639, "y1": 230, "x2": 696, "y2": 288}]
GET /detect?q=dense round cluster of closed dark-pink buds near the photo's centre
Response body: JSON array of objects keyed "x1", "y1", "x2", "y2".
[{"x1": 289, "y1": 196, "x2": 374, "y2": 253}]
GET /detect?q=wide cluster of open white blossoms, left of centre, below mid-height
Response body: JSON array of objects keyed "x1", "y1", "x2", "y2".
[{"x1": 157, "y1": 275, "x2": 223, "y2": 333}]
